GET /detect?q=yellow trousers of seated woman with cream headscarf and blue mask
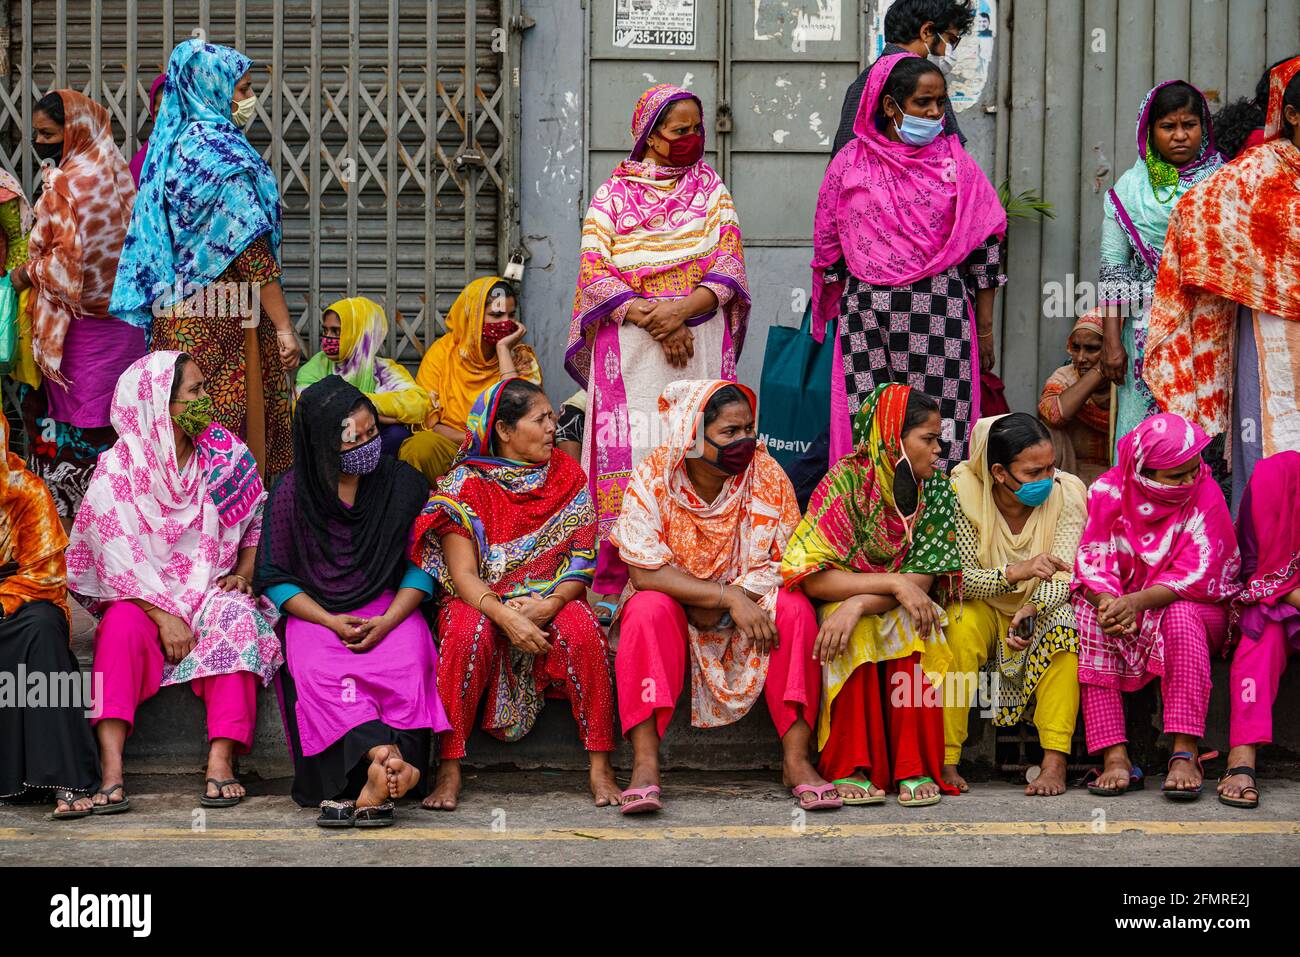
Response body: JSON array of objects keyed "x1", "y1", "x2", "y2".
[{"x1": 944, "y1": 601, "x2": 1079, "y2": 765}]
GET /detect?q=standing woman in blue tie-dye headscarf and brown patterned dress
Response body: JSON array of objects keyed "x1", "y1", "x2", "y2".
[{"x1": 109, "y1": 40, "x2": 299, "y2": 482}]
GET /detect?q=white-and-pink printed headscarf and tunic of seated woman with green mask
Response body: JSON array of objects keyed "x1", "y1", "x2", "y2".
[{"x1": 68, "y1": 351, "x2": 282, "y2": 684}]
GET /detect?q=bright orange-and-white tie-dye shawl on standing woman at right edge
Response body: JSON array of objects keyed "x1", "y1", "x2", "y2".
[{"x1": 1144, "y1": 57, "x2": 1300, "y2": 436}]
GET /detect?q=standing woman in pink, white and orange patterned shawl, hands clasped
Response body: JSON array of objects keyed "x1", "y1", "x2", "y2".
[{"x1": 564, "y1": 83, "x2": 750, "y2": 605}]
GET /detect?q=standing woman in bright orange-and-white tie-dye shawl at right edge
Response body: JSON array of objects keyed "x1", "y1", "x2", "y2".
[{"x1": 1144, "y1": 56, "x2": 1300, "y2": 503}]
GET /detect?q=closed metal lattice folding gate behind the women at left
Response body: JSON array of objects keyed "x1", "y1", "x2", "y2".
[{"x1": 0, "y1": 0, "x2": 521, "y2": 361}]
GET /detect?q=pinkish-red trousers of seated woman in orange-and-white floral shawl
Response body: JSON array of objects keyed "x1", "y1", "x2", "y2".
[{"x1": 614, "y1": 590, "x2": 822, "y2": 737}]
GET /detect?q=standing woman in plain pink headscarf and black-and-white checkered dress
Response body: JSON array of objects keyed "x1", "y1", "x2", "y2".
[{"x1": 813, "y1": 53, "x2": 1006, "y2": 471}]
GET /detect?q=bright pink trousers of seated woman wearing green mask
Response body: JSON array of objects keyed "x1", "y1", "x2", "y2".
[{"x1": 91, "y1": 601, "x2": 257, "y2": 754}]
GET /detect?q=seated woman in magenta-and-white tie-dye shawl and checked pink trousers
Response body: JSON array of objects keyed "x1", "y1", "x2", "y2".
[{"x1": 1074, "y1": 412, "x2": 1242, "y2": 801}]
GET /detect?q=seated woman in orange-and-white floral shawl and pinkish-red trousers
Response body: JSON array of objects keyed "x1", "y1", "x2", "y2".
[{"x1": 610, "y1": 380, "x2": 841, "y2": 814}]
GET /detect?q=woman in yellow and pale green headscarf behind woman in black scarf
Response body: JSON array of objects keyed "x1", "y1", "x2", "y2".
[{"x1": 295, "y1": 295, "x2": 429, "y2": 455}]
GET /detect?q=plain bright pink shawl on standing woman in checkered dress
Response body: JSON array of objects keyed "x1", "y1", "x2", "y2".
[{"x1": 813, "y1": 53, "x2": 1006, "y2": 341}]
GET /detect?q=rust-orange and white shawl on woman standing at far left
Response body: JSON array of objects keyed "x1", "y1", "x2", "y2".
[{"x1": 27, "y1": 90, "x2": 135, "y2": 382}]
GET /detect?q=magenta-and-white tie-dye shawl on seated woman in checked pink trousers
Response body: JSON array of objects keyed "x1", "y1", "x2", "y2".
[{"x1": 1074, "y1": 412, "x2": 1242, "y2": 690}]
